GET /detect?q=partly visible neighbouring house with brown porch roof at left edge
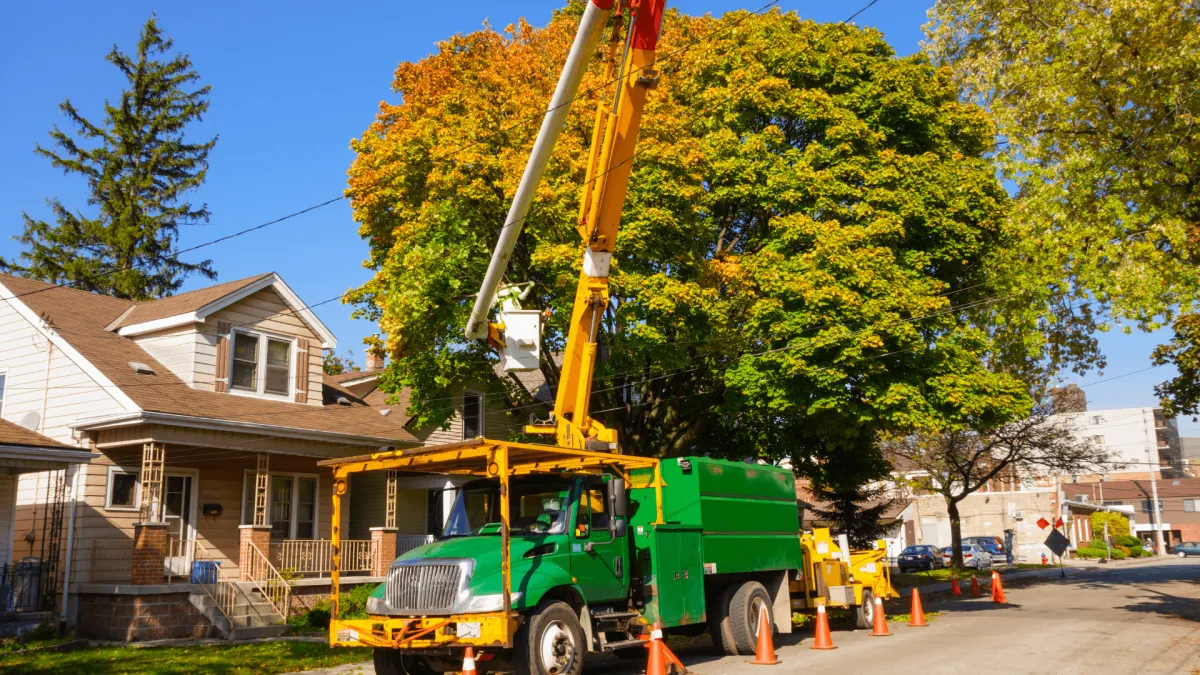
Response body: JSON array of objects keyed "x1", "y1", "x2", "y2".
[{"x1": 0, "y1": 417, "x2": 96, "y2": 637}]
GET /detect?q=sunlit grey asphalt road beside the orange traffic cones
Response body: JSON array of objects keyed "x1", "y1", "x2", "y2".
[{"x1": 290, "y1": 558, "x2": 1200, "y2": 675}]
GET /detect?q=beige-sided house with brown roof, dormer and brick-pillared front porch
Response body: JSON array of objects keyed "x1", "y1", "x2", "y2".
[{"x1": 0, "y1": 274, "x2": 511, "y2": 639}]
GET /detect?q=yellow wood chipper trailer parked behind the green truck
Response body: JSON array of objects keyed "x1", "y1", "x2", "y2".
[{"x1": 791, "y1": 527, "x2": 900, "y2": 628}]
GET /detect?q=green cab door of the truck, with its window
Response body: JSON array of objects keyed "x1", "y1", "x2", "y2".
[{"x1": 571, "y1": 483, "x2": 629, "y2": 604}]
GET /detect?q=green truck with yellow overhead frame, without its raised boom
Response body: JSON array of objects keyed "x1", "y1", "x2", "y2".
[{"x1": 323, "y1": 438, "x2": 804, "y2": 675}]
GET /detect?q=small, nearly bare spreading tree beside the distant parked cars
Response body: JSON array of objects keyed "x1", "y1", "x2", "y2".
[{"x1": 886, "y1": 405, "x2": 1108, "y2": 568}]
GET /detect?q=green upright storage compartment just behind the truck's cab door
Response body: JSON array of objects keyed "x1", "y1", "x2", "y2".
[{"x1": 632, "y1": 525, "x2": 704, "y2": 628}]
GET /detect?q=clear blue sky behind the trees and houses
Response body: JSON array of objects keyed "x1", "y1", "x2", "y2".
[{"x1": 0, "y1": 0, "x2": 1200, "y2": 432}]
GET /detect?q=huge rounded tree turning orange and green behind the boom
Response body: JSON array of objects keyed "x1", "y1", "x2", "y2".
[{"x1": 348, "y1": 2, "x2": 1028, "y2": 461}]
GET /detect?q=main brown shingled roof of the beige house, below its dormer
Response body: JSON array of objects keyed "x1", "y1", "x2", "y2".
[{"x1": 0, "y1": 275, "x2": 419, "y2": 443}]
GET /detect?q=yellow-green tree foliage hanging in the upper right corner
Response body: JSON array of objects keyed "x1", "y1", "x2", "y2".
[{"x1": 925, "y1": 0, "x2": 1200, "y2": 414}]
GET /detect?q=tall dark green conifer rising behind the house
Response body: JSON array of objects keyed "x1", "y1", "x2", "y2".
[{"x1": 0, "y1": 17, "x2": 217, "y2": 300}]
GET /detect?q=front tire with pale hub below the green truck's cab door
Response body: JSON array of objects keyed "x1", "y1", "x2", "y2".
[{"x1": 512, "y1": 602, "x2": 587, "y2": 675}]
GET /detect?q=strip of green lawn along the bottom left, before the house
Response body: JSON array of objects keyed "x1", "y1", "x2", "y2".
[{"x1": 0, "y1": 640, "x2": 371, "y2": 675}]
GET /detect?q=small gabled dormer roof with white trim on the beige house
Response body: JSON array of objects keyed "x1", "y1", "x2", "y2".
[{"x1": 107, "y1": 271, "x2": 337, "y2": 348}]
